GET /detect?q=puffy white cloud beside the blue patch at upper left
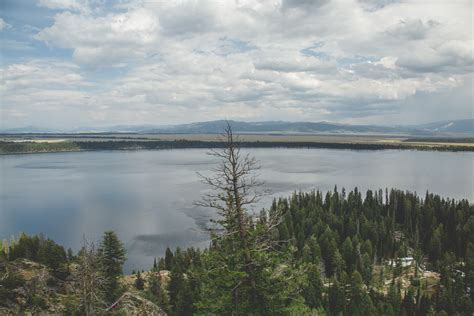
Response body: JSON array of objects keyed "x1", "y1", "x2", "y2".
[{"x1": 35, "y1": 9, "x2": 158, "y2": 66}]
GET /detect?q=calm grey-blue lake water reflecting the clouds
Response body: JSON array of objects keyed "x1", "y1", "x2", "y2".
[{"x1": 0, "y1": 148, "x2": 474, "y2": 271}]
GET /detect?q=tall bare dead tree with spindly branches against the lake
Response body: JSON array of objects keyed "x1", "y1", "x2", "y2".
[{"x1": 196, "y1": 124, "x2": 280, "y2": 312}]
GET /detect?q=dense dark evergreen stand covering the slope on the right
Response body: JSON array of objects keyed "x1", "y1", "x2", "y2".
[{"x1": 272, "y1": 188, "x2": 474, "y2": 315}]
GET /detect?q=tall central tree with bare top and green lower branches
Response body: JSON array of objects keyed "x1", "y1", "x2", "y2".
[{"x1": 194, "y1": 125, "x2": 306, "y2": 315}]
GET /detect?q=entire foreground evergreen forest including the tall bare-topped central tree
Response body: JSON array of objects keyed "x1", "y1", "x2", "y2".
[{"x1": 0, "y1": 130, "x2": 474, "y2": 315}]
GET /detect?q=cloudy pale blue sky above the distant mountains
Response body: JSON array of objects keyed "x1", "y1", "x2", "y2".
[{"x1": 0, "y1": 0, "x2": 474, "y2": 128}]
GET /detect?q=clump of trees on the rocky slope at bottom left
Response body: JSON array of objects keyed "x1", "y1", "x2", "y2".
[{"x1": 0, "y1": 231, "x2": 126, "y2": 315}]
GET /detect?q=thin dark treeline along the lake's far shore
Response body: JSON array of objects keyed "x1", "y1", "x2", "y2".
[{"x1": 0, "y1": 139, "x2": 474, "y2": 154}]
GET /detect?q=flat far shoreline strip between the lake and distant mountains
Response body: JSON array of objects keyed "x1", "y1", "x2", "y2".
[{"x1": 0, "y1": 134, "x2": 474, "y2": 155}]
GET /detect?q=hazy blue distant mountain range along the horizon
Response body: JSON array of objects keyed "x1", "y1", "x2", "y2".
[{"x1": 0, "y1": 119, "x2": 474, "y2": 137}]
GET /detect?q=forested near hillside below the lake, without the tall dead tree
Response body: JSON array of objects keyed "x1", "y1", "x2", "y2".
[{"x1": 0, "y1": 188, "x2": 474, "y2": 315}]
